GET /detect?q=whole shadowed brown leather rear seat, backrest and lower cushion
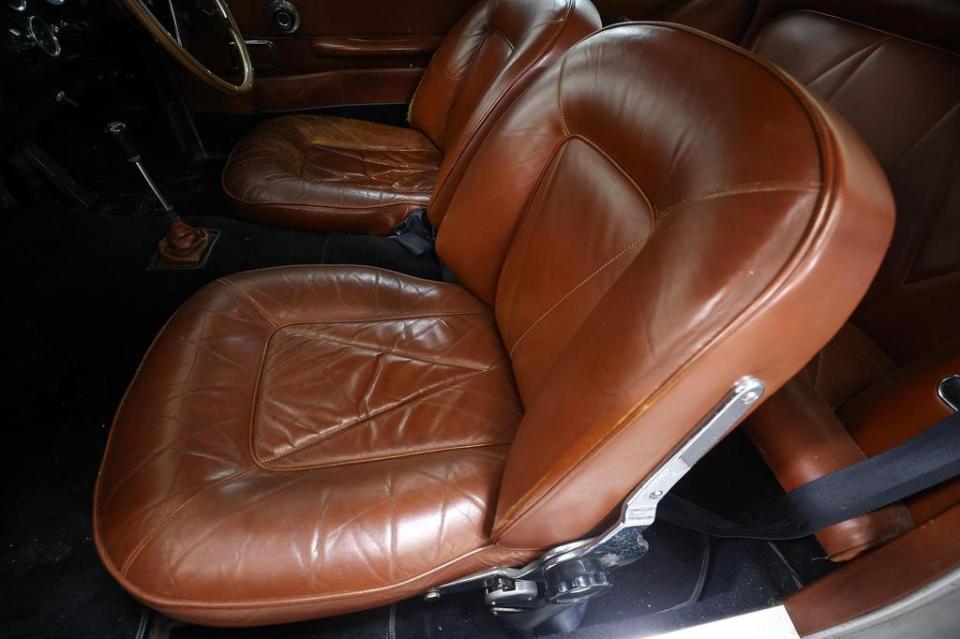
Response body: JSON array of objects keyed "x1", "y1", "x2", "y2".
[{"x1": 597, "y1": 0, "x2": 960, "y2": 561}]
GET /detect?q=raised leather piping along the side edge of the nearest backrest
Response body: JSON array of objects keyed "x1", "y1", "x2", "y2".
[{"x1": 491, "y1": 22, "x2": 837, "y2": 539}]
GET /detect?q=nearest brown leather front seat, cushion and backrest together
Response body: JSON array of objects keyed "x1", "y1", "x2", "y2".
[{"x1": 94, "y1": 23, "x2": 893, "y2": 625}]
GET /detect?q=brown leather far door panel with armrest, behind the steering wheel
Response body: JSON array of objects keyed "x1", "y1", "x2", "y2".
[{"x1": 181, "y1": 0, "x2": 475, "y2": 113}]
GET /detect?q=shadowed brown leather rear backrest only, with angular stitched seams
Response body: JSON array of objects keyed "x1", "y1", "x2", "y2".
[{"x1": 753, "y1": 8, "x2": 960, "y2": 363}]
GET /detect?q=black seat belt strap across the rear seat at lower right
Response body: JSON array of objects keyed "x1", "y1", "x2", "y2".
[{"x1": 657, "y1": 413, "x2": 960, "y2": 540}]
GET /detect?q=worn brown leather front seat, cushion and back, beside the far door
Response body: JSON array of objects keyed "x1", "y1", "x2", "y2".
[{"x1": 223, "y1": 0, "x2": 600, "y2": 235}]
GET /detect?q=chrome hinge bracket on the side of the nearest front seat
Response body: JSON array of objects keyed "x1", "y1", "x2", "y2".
[{"x1": 424, "y1": 376, "x2": 765, "y2": 601}]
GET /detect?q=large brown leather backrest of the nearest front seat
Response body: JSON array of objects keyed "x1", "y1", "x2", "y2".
[{"x1": 437, "y1": 24, "x2": 893, "y2": 548}]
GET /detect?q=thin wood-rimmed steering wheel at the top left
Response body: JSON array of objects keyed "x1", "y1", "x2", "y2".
[{"x1": 122, "y1": 0, "x2": 253, "y2": 95}]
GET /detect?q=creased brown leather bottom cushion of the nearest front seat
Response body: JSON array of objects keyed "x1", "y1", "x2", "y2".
[{"x1": 94, "y1": 266, "x2": 526, "y2": 625}]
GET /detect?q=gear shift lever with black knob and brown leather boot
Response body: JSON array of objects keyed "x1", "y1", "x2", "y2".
[{"x1": 106, "y1": 122, "x2": 220, "y2": 270}]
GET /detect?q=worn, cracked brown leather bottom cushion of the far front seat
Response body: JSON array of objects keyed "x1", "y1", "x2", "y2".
[{"x1": 223, "y1": 115, "x2": 441, "y2": 234}]
